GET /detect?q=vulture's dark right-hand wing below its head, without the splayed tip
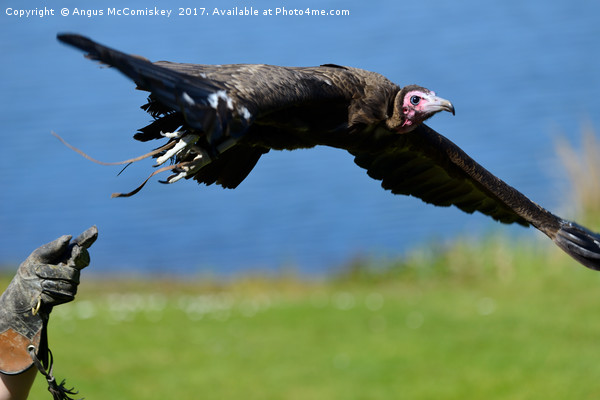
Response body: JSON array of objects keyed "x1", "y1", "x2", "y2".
[{"x1": 352, "y1": 124, "x2": 556, "y2": 227}]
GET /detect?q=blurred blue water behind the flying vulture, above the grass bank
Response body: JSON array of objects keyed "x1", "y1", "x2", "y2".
[{"x1": 0, "y1": 0, "x2": 600, "y2": 275}]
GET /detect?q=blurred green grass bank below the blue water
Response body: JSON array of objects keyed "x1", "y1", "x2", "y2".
[{"x1": 4, "y1": 237, "x2": 600, "y2": 400}]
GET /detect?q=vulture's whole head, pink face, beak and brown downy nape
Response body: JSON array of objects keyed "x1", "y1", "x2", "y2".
[{"x1": 388, "y1": 85, "x2": 454, "y2": 133}]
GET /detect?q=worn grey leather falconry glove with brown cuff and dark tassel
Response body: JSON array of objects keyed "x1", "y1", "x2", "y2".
[{"x1": 0, "y1": 226, "x2": 98, "y2": 399}]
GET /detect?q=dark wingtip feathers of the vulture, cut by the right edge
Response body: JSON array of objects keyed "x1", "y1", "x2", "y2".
[{"x1": 552, "y1": 220, "x2": 600, "y2": 271}]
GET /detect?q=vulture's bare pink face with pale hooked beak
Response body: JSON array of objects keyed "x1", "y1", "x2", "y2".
[{"x1": 398, "y1": 88, "x2": 454, "y2": 133}]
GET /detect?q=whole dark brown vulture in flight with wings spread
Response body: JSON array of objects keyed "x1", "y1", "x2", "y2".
[{"x1": 57, "y1": 34, "x2": 600, "y2": 270}]
